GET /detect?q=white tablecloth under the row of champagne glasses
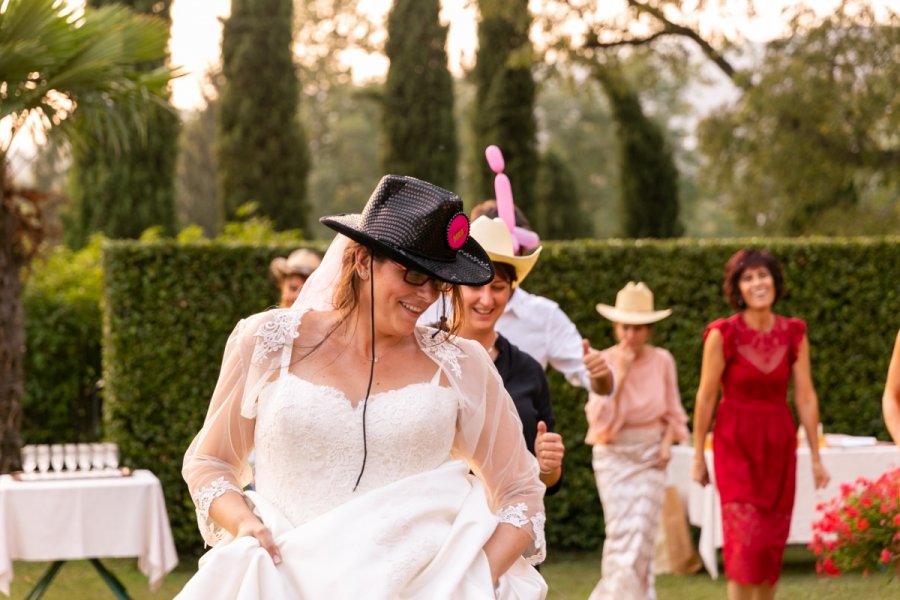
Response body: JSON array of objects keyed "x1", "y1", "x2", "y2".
[{"x1": 0, "y1": 470, "x2": 178, "y2": 596}]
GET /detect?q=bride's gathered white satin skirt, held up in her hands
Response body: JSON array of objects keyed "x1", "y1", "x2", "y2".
[{"x1": 177, "y1": 460, "x2": 547, "y2": 600}]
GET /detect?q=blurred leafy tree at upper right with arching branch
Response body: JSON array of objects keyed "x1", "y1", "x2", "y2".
[{"x1": 538, "y1": 0, "x2": 900, "y2": 235}]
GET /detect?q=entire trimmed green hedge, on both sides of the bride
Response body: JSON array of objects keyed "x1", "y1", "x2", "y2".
[{"x1": 103, "y1": 237, "x2": 900, "y2": 552}]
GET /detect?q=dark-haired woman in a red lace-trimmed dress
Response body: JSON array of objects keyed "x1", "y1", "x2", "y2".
[{"x1": 693, "y1": 249, "x2": 828, "y2": 600}]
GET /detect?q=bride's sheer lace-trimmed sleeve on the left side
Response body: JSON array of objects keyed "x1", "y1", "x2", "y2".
[{"x1": 182, "y1": 310, "x2": 299, "y2": 545}]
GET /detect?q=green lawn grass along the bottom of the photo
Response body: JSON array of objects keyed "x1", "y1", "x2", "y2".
[{"x1": 11, "y1": 547, "x2": 900, "y2": 600}]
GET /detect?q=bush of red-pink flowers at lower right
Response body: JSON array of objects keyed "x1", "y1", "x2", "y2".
[{"x1": 809, "y1": 469, "x2": 900, "y2": 575}]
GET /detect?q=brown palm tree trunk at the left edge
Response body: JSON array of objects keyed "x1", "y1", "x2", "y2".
[{"x1": 0, "y1": 165, "x2": 25, "y2": 473}]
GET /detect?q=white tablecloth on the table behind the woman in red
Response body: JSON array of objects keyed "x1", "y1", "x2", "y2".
[{"x1": 667, "y1": 444, "x2": 900, "y2": 579}]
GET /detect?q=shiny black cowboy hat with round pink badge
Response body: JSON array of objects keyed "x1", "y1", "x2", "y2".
[{"x1": 319, "y1": 175, "x2": 494, "y2": 285}]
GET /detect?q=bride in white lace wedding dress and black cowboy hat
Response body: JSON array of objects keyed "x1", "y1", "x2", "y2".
[{"x1": 179, "y1": 175, "x2": 547, "y2": 599}]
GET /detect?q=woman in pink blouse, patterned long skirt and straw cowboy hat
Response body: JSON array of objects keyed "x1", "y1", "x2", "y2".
[{"x1": 584, "y1": 281, "x2": 688, "y2": 600}]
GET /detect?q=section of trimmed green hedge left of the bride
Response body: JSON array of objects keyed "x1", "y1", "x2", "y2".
[{"x1": 103, "y1": 241, "x2": 306, "y2": 553}]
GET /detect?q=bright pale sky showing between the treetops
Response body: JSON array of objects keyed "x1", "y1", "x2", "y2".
[{"x1": 169, "y1": 0, "x2": 900, "y2": 109}]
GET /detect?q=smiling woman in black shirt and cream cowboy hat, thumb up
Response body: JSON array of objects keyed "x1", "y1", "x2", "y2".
[{"x1": 459, "y1": 217, "x2": 565, "y2": 494}]
